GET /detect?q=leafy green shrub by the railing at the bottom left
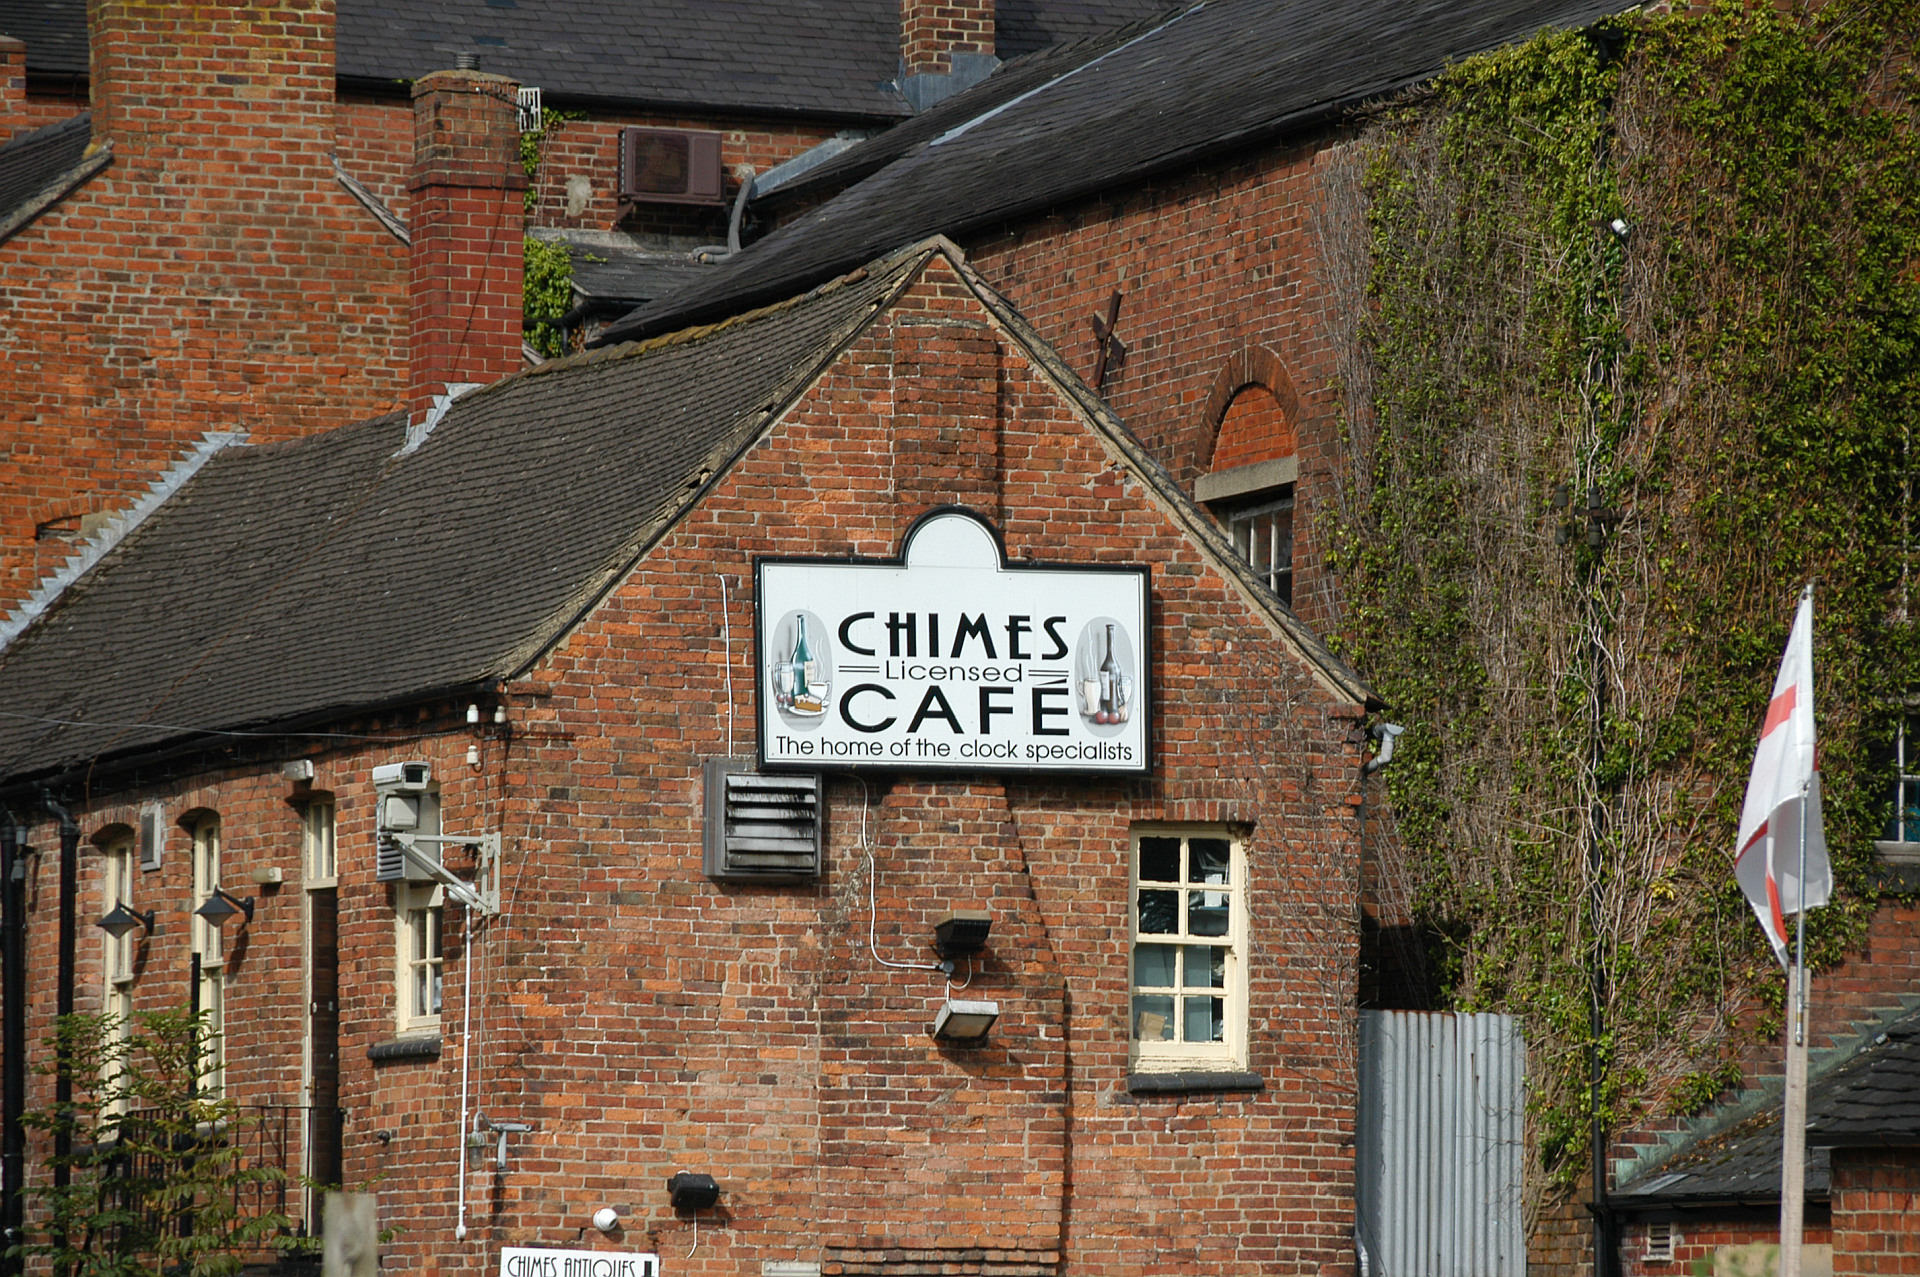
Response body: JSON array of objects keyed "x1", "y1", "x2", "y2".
[{"x1": 12, "y1": 1010, "x2": 288, "y2": 1277}]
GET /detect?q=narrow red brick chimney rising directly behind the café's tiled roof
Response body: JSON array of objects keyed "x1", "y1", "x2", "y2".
[{"x1": 407, "y1": 69, "x2": 526, "y2": 422}]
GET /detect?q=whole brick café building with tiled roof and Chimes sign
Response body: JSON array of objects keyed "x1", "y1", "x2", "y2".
[{"x1": 0, "y1": 240, "x2": 1369, "y2": 1273}]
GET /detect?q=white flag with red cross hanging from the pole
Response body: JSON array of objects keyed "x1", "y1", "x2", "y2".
[{"x1": 1734, "y1": 586, "x2": 1834, "y2": 964}]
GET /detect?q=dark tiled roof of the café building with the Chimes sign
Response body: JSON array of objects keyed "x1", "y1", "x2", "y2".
[{"x1": 0, "y1": 234, "x2": 1371, "y2": 783}]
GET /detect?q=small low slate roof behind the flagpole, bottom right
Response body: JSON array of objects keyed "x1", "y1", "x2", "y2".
[{"x1": 1613, "y1": 1010, "x2": 1920, "y2": 1210}]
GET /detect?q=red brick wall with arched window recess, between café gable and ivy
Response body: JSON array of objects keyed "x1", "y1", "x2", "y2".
[{"x1": 968, "y1": 144, "x2": 1338, "y2": 624}]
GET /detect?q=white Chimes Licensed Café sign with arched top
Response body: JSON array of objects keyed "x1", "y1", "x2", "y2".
[{"x1": 755, "y1": 507, "x2": 1152, "y2": 774}]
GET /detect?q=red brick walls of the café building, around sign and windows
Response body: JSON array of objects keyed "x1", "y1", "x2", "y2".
[{"x1": 15, "y1": 251, "x2": 1359, "y2": 1277}]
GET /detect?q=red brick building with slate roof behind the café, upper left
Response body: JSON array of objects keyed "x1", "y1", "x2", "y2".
[{"x1": 0, "y1": 0, "x2": 1154, "y2": 611}]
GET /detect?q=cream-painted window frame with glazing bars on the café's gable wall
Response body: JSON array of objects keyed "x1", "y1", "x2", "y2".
[{"x1": 1127, "y1": 824, "x2": 1248, "y2": 1073}]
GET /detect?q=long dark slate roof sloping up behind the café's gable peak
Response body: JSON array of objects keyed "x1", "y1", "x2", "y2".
[{"x1": 601, "y1": 0, "x2": 1630, "y2": 342}]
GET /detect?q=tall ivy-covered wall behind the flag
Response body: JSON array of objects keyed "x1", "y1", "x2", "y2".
[{"x1": 1321, "y1": 0, "x2": 1920, "y2": 1194}]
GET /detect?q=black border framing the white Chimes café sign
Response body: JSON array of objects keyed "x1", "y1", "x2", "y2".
[{"x1": 753, "y1": 505, "x2": 1160, "y2": 778}]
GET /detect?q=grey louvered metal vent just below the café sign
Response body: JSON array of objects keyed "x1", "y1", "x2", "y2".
[{"x1": 701, "y1": 759, "x2": 826, "y2": 881}]
